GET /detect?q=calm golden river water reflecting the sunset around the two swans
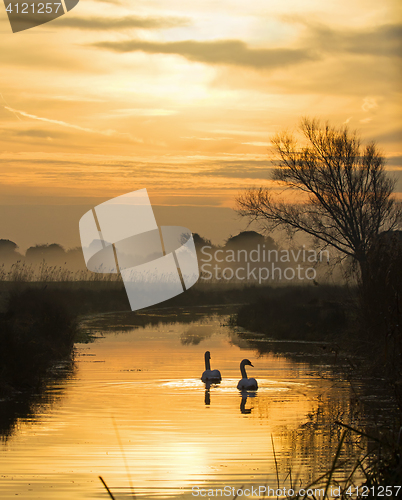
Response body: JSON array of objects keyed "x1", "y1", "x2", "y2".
[{"x1": 0, "y1": 309, "x2": 364, "y2": 500}]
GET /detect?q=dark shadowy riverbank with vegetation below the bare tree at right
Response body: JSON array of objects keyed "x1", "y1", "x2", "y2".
[{"x1": 232, "y1": 284, "x2": 402, "y2": 490}]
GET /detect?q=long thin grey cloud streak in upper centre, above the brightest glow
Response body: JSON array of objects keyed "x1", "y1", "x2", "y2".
[{"x1": 91, "y1": 40, "x2": 317, "y2": 68}]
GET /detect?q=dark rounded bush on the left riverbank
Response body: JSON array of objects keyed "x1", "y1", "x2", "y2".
[{"x1": 0, "y1": 288, "x2": 76, "y2": 395}]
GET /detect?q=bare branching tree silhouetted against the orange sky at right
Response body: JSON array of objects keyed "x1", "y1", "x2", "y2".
[{"x1": 236, "y1": 118, "x2": 402, "y2": 280}]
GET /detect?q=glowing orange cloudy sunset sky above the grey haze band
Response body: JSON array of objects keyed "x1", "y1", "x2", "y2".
[{"x1": 0, "y1": 0, "x2": 402, "y2": 246}]
